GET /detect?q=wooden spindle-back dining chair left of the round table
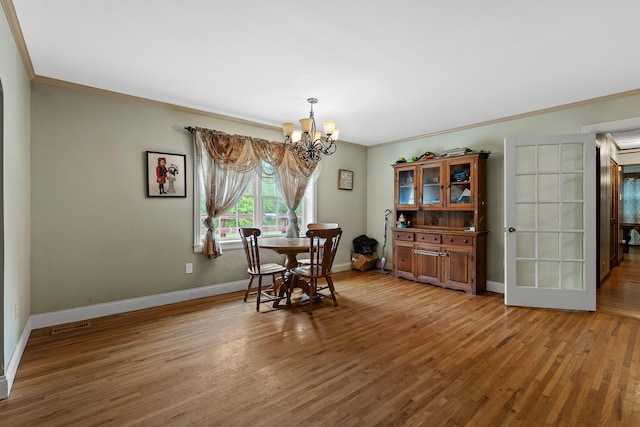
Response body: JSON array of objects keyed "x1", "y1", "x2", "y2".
[{"x1": 238, "y1": 227, "x2": 289, "y2": 311}]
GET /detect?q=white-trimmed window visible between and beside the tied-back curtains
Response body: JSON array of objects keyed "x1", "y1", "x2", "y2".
[{"x1": 193, "y1": 163, "x2": 316, "y2": 252}]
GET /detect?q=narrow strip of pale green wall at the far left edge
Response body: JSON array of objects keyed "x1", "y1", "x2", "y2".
[{"x1": 0, "y1": 7, "x2": 30, "y2": 378}]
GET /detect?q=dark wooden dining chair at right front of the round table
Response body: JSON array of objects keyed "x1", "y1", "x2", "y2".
[{"x1": 291, "y1": 228, "x2": 342, "y2": 314}]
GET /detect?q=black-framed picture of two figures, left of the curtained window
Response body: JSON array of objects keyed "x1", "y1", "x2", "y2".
[{"x1": 147, "y1": 151, "x2": 187, "y2": 197}]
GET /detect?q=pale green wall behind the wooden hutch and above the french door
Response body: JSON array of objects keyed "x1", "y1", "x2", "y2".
[{"x1": 367, "y1": 95, "x2": 640, "y2": 283}]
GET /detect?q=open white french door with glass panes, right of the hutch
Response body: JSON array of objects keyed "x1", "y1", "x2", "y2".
[{"x1": 504, "y1": 134, "x2": 597, "y2": 311}]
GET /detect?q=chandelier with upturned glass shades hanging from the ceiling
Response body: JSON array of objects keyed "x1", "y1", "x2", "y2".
[{"x1": 282, "y1": 98, "x2": 339, "y2": 163}]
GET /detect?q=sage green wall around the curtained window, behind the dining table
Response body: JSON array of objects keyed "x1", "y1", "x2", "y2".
[{"x1": 31, "y1": 83, "x2": 367, "y2": 314}]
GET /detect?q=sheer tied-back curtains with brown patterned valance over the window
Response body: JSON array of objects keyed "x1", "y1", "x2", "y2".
[{"x1": 195, "y1": 128, "x2": 317, "y2": 259}]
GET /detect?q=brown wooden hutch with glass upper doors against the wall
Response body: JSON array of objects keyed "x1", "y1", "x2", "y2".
[{"x1": 392, "y1": 152, "x2": 489, "y2": 294}]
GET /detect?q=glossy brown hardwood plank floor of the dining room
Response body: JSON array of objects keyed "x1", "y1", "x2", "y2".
[{"x1": 0, "y1": 271, "x2": 640, "y2": 426}]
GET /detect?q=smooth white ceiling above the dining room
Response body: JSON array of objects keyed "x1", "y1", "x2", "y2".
[{"x1": 8, "y1": 0, "x2": 640, "y2": 145}]
